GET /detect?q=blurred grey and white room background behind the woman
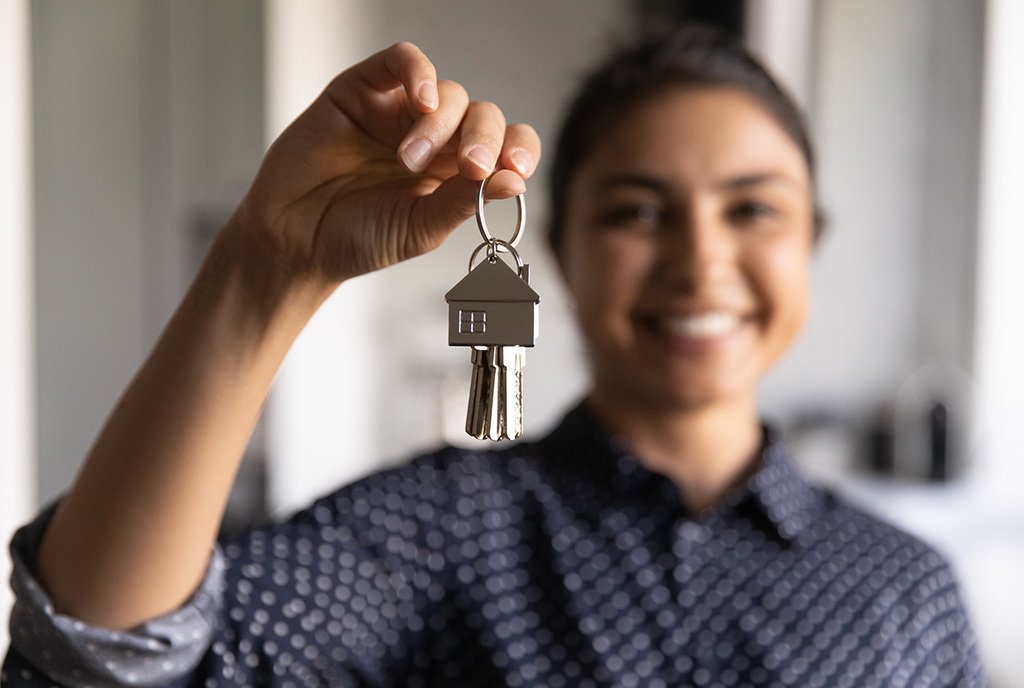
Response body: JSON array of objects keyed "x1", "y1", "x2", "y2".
[{"x1": 0, "y1": 0, "x2": 1024, "y2": 687}]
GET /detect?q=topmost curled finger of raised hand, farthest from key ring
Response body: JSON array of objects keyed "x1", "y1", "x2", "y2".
[{"x1": 328, "y1": 42, "x2": 438, "y2": 113}]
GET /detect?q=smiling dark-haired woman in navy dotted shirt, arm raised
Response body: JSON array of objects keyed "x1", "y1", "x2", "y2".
[{"x1": 5, "y1": 29, "x2": 983, "y2": 686}]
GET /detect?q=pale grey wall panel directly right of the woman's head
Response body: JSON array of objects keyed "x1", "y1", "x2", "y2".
[{"x1": 765, "y1": 0, "x2": 929, "y2": 419}]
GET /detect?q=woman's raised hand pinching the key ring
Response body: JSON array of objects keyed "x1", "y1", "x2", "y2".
[{"x1": 229, "y1": 43, "x2": 541, "y2": 284}]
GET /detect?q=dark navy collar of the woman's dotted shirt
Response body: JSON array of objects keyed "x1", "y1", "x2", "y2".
[{"x1": 543, "y1": 402, "x2": 824, "y2": 546}]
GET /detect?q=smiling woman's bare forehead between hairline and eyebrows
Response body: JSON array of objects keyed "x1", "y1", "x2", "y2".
[{"x1": 580, "y1": 87, "x2": 809, "y2": 184}]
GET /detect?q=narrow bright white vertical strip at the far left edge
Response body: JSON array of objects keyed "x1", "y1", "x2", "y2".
[{"x1": 0, "y1": 0, "x2": 36, "y2": 648}]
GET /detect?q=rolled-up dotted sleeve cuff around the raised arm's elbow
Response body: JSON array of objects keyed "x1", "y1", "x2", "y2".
[{"x1": 2, "y1": 505, "x2": 225, "y2": 688}]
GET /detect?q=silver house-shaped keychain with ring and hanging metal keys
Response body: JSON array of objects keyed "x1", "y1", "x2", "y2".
[{"x1": 444, "y1": 182, "x2": 541, "y2": 440}]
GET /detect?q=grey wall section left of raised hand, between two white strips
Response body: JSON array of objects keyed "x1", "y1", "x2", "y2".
[{"x1": 32, "y1": 0, "x2": 262, "y2": 501}]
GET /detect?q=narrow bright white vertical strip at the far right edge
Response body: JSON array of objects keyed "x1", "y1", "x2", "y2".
[{"x1": 975, "y1": 0, "x2": 1024, "y2": 505}]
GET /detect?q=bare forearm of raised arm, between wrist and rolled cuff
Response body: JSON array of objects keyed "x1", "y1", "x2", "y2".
[{"x1": 38, "y1": 220, "x2": 331, "y2": 628}]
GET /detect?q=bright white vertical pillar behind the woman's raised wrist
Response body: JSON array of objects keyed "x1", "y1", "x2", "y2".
[{"x1": 265, "y1": 0, "x2": 379, "y2": 512}]
